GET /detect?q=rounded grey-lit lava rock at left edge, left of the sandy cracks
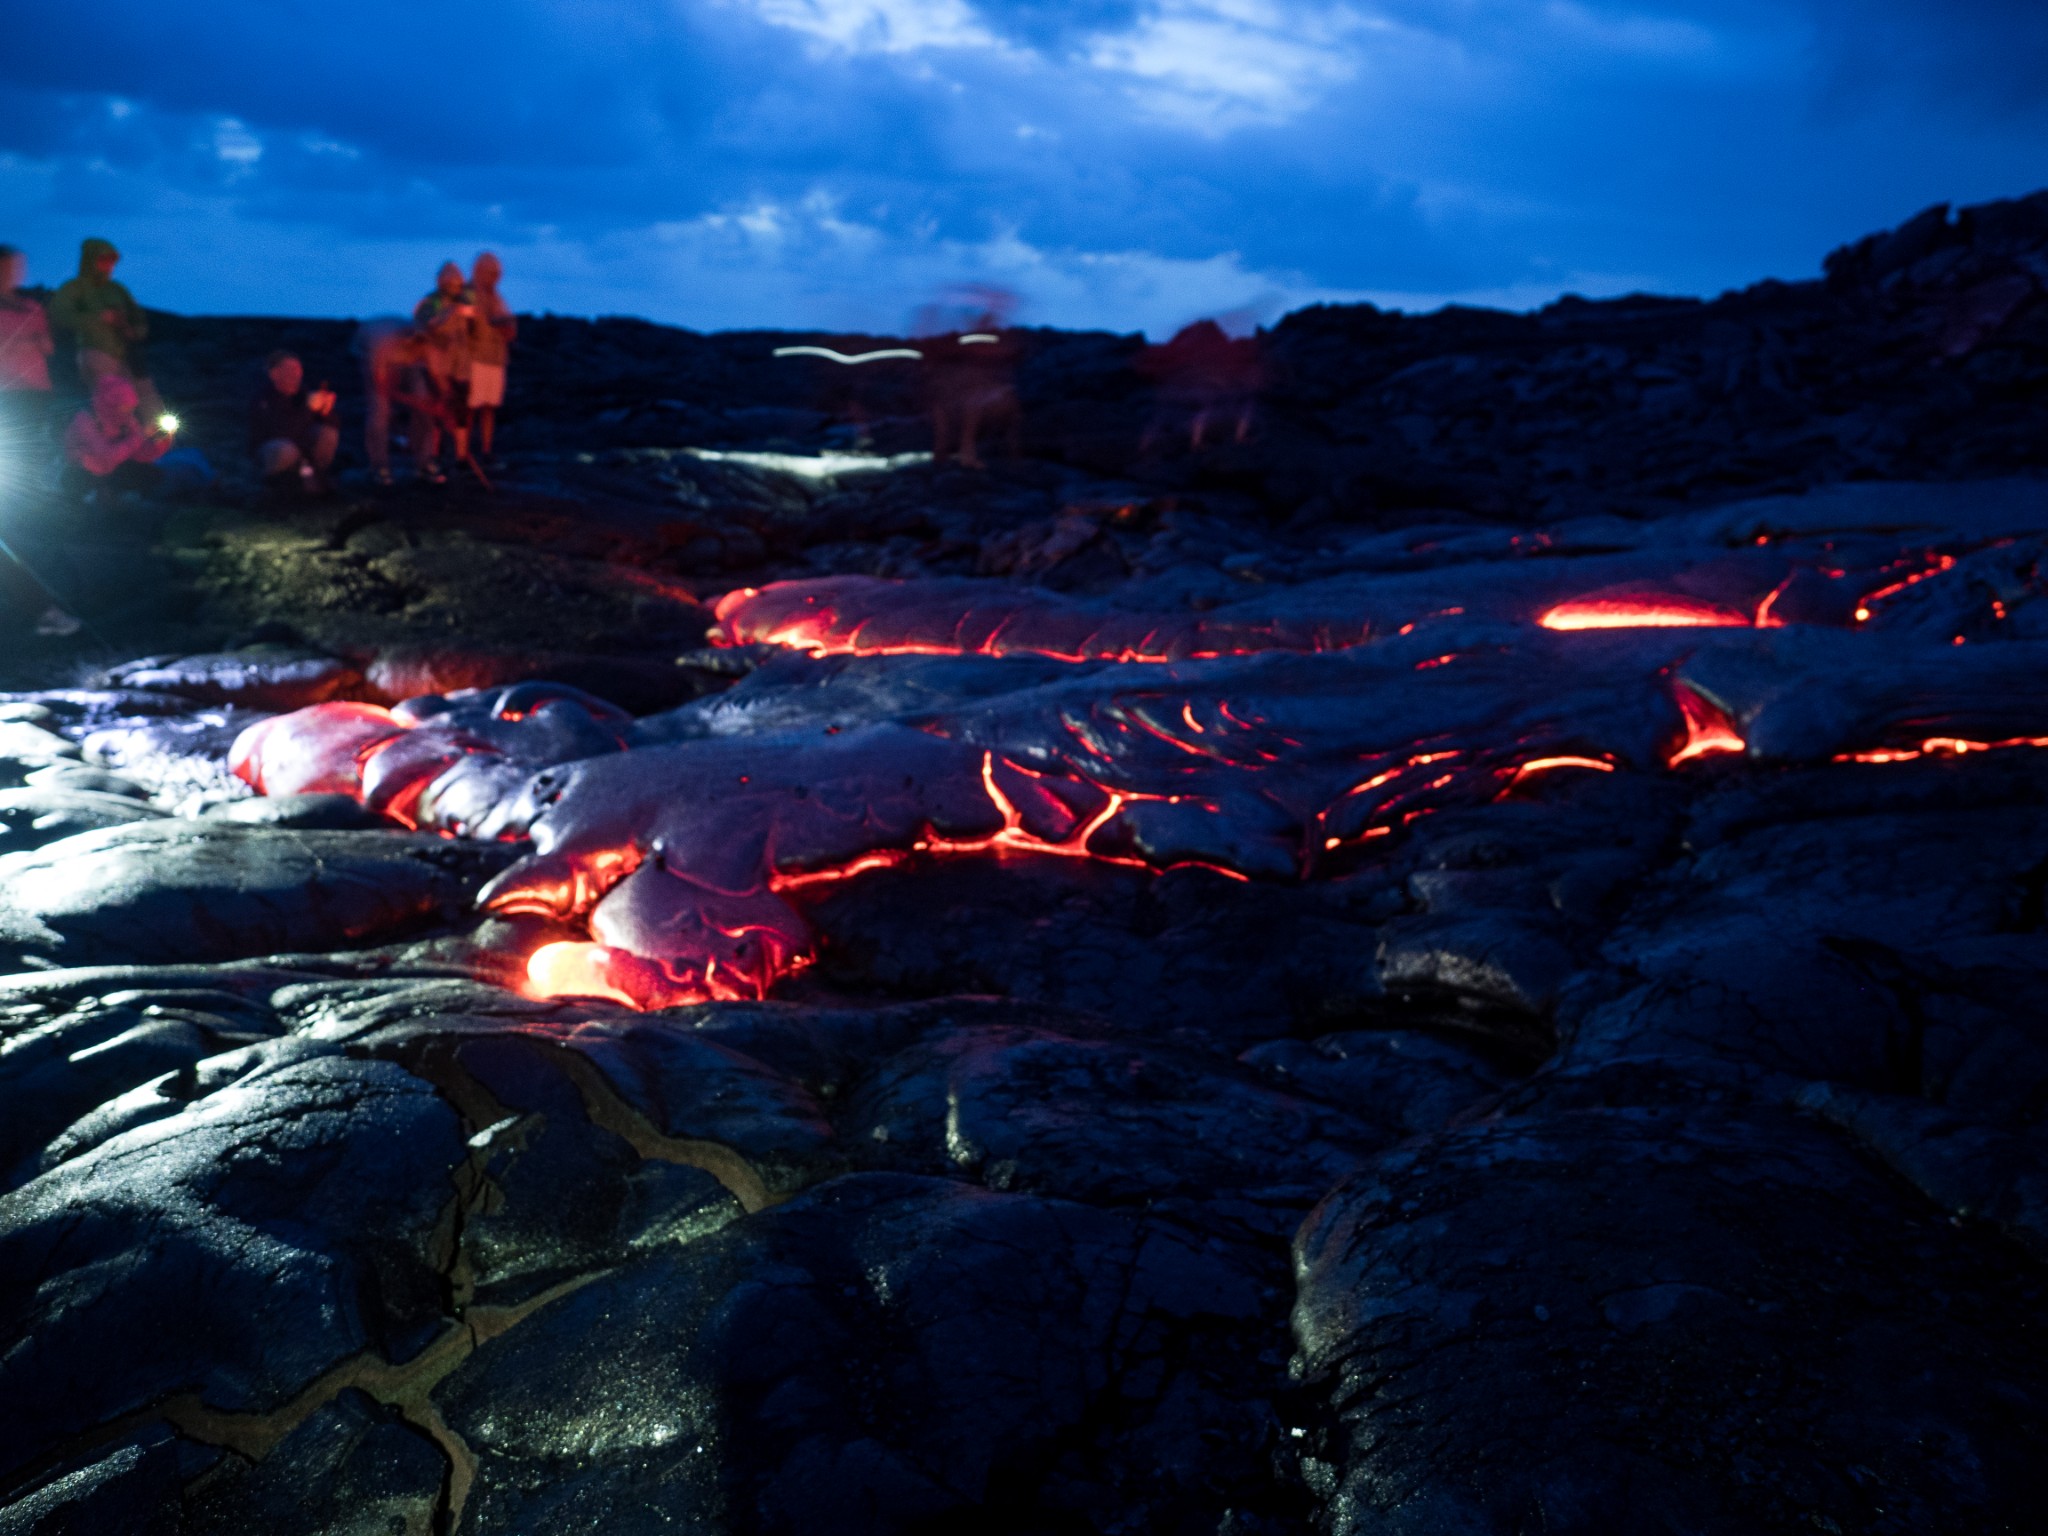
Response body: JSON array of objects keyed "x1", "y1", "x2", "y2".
[{"x1": 0, "y1": 1059, "x2": 465, "y2": 1477}]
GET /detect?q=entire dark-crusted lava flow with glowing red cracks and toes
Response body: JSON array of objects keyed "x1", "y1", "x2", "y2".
[{"x1": 236, "y1": 495, "x2": 2048, "y2": 1024}]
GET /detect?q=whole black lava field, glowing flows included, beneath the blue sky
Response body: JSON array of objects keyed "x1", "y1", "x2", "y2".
[{"x1": 0, "y1": 197, "x2": 2048, "y2": 1536}]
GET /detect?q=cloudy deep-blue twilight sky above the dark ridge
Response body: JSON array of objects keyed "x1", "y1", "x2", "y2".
[{"x1": 0, "y1": 0, "x2": 2048, "y2": 334}]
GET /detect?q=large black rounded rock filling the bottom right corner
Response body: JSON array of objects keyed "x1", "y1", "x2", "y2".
[{"x1": 1294, "y1": 1110, "x2": 2048, "y2": 1534}]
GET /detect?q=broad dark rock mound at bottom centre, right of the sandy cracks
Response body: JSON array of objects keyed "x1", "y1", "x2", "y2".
[{"x1": 436, "y1": 1176, "x2": 1278, "y2": 1532}]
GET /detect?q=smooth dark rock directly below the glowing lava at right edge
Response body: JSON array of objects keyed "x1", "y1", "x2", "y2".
[{"x1": 1565, "y1": 762, "x2": 2048, "y2": 1092}]
